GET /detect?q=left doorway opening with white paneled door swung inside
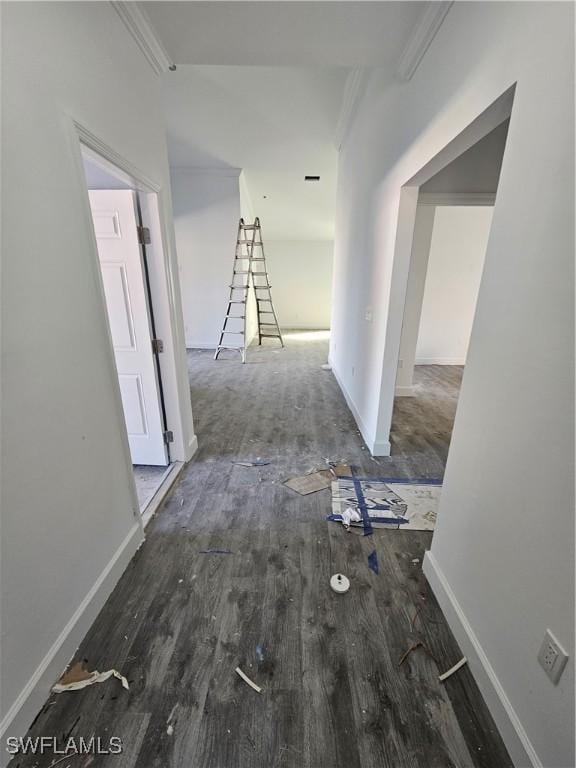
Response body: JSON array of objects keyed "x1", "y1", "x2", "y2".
[{"x1": 82, "y1": 148, "x2": 171, "y2": 513}]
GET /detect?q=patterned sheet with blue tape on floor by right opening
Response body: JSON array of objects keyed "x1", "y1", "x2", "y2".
[{"x1": 328, "y1": 477, "x2": 442, "y2": 533}]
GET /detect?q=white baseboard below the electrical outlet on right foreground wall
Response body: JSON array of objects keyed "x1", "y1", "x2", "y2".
[{"x1": 422, "y1": 552, "x2": 544, "y2": 768}]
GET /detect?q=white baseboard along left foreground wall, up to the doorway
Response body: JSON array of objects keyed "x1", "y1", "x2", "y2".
[{"x1": 0, "y1": 520, "x2": 144, "y2": 767}]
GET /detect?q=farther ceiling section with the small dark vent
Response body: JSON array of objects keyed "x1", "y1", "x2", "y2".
[{"x1": 164, "y1": 66, "x2": 346, "y2": 240}]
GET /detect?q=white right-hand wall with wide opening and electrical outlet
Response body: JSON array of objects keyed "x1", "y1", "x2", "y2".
[{"x1": 330, "y1": 2, "x2": 574, "y2": 768}]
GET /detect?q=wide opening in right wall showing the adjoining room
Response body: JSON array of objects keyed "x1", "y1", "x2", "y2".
[{"x1": 390, "y1": 119, "x2": 509, "y2": 481}]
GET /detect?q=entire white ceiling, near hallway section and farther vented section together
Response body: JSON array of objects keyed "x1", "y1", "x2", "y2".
[{"x1": 141, "y1": 0, "x2": 425, "y2": 240}]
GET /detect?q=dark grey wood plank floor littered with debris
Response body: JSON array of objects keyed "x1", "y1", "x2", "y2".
[{"x1": 12, "y1": 340, "x2": 511, "y2": 768}]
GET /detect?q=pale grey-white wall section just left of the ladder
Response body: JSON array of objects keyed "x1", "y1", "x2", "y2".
[{"x1": 170, "y1": 168, "x2": 240, "y2": 349}]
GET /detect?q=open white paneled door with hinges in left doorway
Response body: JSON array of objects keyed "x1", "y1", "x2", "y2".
[{"x1": 89, "y1": 189, "x2": 168, "y2": 466}]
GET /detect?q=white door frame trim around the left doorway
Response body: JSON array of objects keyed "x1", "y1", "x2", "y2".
[{"x1": 65, "y1": 116, "x2": 198, "y2": 510}]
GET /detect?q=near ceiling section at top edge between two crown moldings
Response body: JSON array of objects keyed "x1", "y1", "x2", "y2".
[{"x1": 143, "y1": 0, "x2": 425, "y2": 67}]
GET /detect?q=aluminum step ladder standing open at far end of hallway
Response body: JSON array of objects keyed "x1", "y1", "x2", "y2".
[{"x1": 214, "y1": 217, "x2": 284, "y2": 363}]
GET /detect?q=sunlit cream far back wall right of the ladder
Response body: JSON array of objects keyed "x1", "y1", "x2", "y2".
[{"x1": 265, "y1": 240, "x2": 333, "y2": 329}]
